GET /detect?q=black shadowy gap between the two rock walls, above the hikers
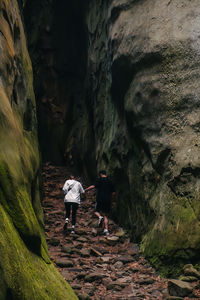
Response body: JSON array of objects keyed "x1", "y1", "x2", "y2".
[{"x1": 24, "y1": 0, "x2": 88, "y2": 164}]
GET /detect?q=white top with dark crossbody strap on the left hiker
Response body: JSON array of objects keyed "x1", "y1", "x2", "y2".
[{"x1": 63, "y1": 179, "x2": 85, "y2": 204}]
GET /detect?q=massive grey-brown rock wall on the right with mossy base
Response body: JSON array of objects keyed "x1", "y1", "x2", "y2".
[{"x1": 82, "y1": 0, "x2": 200, "y2": 272}]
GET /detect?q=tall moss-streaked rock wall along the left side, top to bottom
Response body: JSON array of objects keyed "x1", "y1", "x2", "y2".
[{"x1": 0, "y1": 0, "x2": 76, "y2": 299}]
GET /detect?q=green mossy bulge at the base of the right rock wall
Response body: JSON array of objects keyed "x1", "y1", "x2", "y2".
[{"x1": 141, "y1": 189, "x2": 200, "y2": 276}]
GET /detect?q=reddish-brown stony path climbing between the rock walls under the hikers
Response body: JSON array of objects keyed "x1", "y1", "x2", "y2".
[{"x1": 43, "y1": 164, "x2": 197, "y2": 300}]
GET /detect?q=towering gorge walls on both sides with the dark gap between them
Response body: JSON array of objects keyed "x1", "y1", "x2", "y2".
[{"x1": 0, "y1": 0, "x2": 200, "y2": 300}]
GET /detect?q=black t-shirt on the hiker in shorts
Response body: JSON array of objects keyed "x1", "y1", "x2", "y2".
[{"x1": 94, "y1": 177, "x2": 115, "y2": 201}]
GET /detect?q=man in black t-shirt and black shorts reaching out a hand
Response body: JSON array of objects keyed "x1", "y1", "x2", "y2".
[{"x1": 85, "y1": 170, "x2": 115, "y2": 235}]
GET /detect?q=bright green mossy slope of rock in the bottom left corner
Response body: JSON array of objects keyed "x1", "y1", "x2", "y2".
[{"x1": 0, "y1": 205, "x2": 77, "y2": 300}]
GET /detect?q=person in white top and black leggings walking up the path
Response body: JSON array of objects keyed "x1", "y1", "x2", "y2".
[{"x1": 63, "y1": 175, "x2": 85, "y2": 233}]
